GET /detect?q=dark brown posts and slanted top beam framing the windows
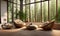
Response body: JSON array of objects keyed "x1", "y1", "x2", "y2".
[{"x1": 8, "y1": 0, "x2": 58, "y2": 22}]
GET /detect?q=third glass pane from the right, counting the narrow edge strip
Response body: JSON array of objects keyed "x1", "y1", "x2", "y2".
[{"x1": 42, "y1": 1, "x2": 48, "y2": 22}]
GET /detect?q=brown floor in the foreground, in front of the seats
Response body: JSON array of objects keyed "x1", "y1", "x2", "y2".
[{"x1": 0, "y1": 29, "x2": 60, "y2": 36}]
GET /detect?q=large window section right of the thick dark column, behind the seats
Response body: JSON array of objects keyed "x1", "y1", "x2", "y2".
[{"x1": 23, "y1": 0, "x2": 56, "y2": 22}]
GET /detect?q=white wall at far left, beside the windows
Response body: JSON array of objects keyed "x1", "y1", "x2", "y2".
[{"x1": 1, "y1": 1, "x2": 7, "y2": 23}]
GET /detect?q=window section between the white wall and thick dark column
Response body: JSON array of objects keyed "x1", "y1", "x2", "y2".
[{"x1": 7, "y1": 0, "x2": 20, "y2": 22}]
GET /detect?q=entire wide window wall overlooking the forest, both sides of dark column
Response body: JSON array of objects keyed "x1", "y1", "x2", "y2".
[{"x1": 8, "y1": 0, "x2": 56, "y2": 22}]
